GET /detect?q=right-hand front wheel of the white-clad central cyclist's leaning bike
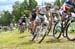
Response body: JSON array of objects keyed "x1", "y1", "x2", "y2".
[{"x1": 35, "y1": 26, "x2": 47, "y2": 43}]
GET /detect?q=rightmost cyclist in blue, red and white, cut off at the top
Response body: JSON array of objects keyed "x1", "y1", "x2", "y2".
[{"x1": 59, "y1": 0, "x2": 75, "y2": 36}]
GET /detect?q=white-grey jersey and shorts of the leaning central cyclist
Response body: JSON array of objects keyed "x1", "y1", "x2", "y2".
[{"x1": 35, "y1": 7, "x2": 50, "y2": 23}]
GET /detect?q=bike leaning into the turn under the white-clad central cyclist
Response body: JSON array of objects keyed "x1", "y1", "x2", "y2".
[{"x1": 32, "y1": 15, "x2": 48, "y2": 43}]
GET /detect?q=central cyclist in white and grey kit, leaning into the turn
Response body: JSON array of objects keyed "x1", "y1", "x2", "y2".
[{"x1": 33, "y1": 3, "x2": 52, "y2": 33}]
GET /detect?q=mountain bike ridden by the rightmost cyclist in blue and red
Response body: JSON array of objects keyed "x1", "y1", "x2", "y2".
[{"x1": 53, "y1": 14, "x2": 75, "y2": 41}]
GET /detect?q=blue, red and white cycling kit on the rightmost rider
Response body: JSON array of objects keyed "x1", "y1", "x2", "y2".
[{"x1": 59, "y1": 0, "x2": 75, "y2": 16}]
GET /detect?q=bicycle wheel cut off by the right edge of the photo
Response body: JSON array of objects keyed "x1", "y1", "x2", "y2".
[{"x1": 66, "y1": 21, "x2": 75, "y2": 41}]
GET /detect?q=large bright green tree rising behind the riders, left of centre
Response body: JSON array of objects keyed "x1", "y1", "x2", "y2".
[{"x1": 12, "y1": 0, "x2": 37, "y2": 22}]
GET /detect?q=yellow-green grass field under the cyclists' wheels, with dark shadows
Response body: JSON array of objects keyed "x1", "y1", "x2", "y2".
[{"x1": 0, "y1": 31, "x2": 75, "y2": 49}]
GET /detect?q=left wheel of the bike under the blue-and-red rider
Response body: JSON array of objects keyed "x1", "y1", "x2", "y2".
[{"x1": 53, "y1": 22, "x2": 61, "y2": 39}]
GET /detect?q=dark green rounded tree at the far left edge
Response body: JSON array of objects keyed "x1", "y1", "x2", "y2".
[{"x1": 0, "y1": 11, "x2": 13, "y2": 25}]
